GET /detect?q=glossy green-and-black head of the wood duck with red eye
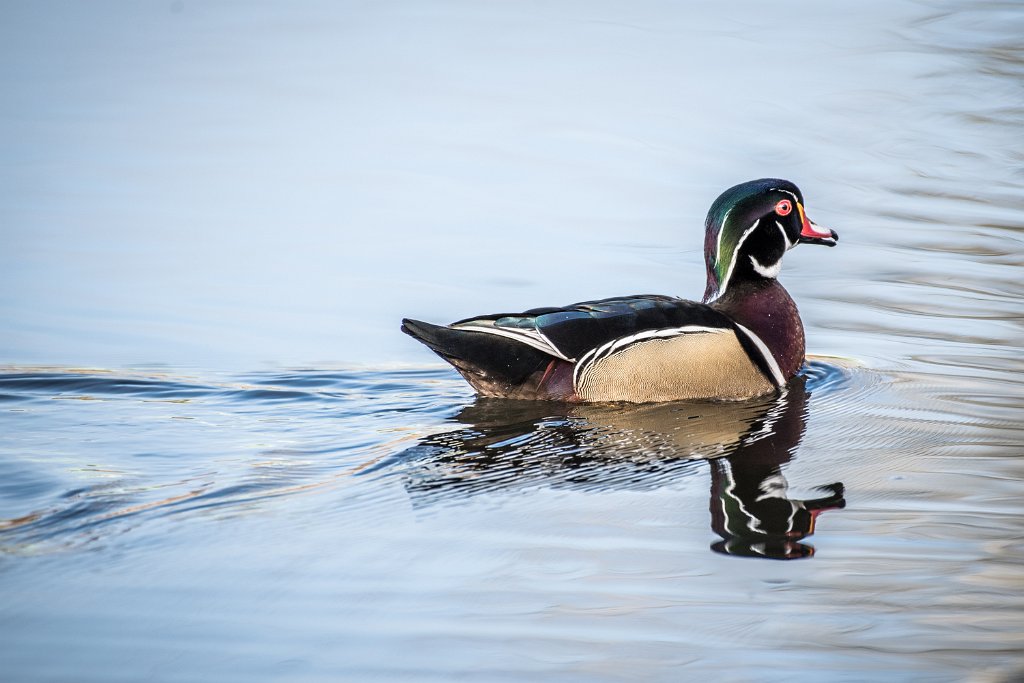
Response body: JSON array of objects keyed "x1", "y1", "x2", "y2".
[{"x1": 703, "y1": 178, "x2": 839, "y2": 303}]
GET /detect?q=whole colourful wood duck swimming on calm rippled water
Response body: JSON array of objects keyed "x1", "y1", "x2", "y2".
[{"x1": 401, "y1": 178, "x2": 839, "y2": 403}]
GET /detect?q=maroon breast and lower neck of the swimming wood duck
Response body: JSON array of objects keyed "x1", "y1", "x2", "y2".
[{"x1": 712, "y1": 279, "x2": 805, "y2": 379}]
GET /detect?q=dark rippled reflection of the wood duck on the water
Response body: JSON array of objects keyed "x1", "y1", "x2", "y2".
[{"x1": 387, "y1": 377, "x2": 846, "y2": 559}]
